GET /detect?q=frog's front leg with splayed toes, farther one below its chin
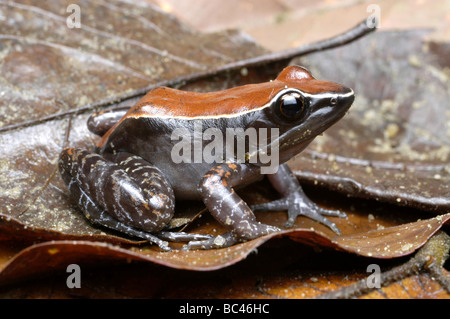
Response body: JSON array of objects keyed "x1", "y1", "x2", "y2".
[{"x1": 252, "y1": 164, "x2": 347, "y2": 235}]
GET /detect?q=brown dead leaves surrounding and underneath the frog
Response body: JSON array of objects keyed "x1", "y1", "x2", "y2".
[{"x1": 0, "y1": 1, "x2": 450, "y2": 288}]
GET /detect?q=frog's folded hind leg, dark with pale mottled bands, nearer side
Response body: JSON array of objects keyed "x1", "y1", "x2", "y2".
[{"x1": 59, "y1": 148, "x2": 185, "y2": 250}]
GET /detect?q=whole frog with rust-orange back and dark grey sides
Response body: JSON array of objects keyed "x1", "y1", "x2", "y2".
[{"x1": 58, "y1": 65, "x2": 355, "y2": 251}]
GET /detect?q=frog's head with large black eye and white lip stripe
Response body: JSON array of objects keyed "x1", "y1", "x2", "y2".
[{"x1": 265, "y1": 66, "x2": 355, "y2": 163}]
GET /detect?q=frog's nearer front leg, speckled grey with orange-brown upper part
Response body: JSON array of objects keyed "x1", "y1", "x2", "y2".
[{"x1": 185, "y1": 163, "x2": 280, "y2": 249}]
